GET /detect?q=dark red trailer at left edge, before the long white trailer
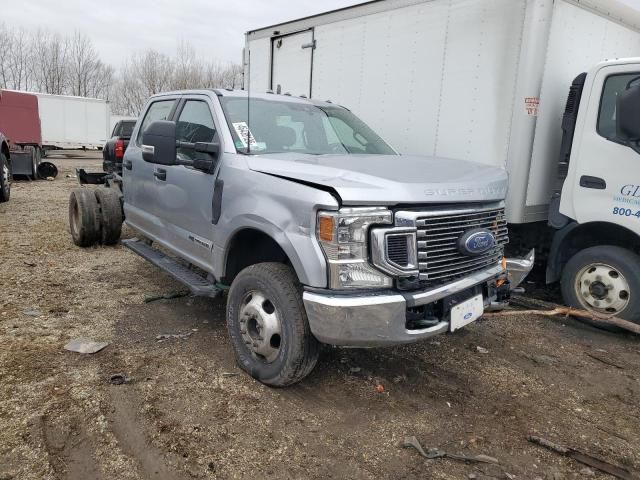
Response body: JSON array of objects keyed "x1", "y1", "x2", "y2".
[{"x1": 0, "y1": 90, "x2": 42, "y2": 180}]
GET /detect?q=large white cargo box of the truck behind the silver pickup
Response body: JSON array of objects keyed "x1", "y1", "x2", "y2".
[{"x1": 245, "y1": 0, "x2": 640, "y2": 223}]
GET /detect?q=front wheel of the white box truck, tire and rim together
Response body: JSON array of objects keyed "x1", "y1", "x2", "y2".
[{"x1": 562, "y1": 245, "x2": 640, "y2": 324}]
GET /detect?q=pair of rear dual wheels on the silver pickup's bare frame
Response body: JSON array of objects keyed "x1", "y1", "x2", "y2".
[{"x1": 69, "y1": 188, "x2": 123, "y2": 247}]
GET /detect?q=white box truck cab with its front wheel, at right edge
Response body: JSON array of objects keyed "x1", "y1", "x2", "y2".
[{"x1": 547, "y1": 58, "x2": 640, "y2": 320}]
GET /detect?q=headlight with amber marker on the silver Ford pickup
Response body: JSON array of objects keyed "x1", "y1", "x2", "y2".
[{"x1": 317, "y1": 207, "x2": 393, "y2": 289}]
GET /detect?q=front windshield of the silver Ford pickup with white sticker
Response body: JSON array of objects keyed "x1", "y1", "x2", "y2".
[{"x1": 220, "y1": 96, "x2": 396, "y2": 155}]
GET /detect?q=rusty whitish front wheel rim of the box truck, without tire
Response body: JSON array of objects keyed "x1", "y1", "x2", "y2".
[{"x1": 575, "y1": 263, "x2": 631, "y2": 315}]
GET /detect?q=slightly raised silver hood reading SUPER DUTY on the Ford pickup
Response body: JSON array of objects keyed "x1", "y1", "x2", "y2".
[{"x1": 248, "y1": 153, "x2": 507, "y2": 205}]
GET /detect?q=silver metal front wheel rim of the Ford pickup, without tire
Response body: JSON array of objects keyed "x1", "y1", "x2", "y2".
[{"x1": 240, "y1": 290, "x2": 282, "y2": 363}]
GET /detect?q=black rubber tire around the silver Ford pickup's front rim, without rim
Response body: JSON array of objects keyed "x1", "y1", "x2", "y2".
[{"x1": 227, "y1": 263, "x2": 320, "y2": 387}]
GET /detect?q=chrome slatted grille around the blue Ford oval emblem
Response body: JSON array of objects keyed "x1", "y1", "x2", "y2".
[{"x1": 416, "y1": 207, "x2": 509, "y2": 282}]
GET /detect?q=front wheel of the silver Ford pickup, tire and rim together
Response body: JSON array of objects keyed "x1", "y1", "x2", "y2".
[{"x1": 227, "y1": 263, "x2": 320, "y2": 387}]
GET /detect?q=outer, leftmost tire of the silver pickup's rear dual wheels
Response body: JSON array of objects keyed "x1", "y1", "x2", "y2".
[{"x1": 69, "y1": 188, "x2": 100, "y2": 247}]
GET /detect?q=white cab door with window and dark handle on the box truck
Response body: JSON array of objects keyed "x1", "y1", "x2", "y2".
[{"x1": 561, "y1": 64, "x2": 640, "y2": 233}]
